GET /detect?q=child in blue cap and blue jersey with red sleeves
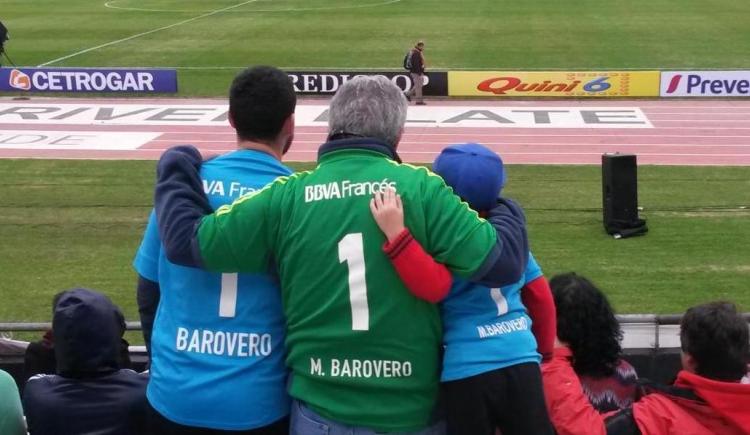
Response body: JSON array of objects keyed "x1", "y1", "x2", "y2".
[{"x1": 371, "y1": 143, "x2": 556, "y2": 435}]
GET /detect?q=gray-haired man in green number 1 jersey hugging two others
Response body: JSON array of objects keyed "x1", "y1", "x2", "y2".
[{"x1": 155, "y1": 77, "x2": 528, "y2": 435}]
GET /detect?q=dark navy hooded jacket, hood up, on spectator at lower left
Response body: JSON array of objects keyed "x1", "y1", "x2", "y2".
[{"x1": 23, "y1": 289, "x2": 148, "y2": 435}]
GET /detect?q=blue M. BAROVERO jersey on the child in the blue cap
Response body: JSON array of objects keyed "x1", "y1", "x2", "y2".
[{"x1": 441, "y1": 253, "x2": 542, "y2": 382}]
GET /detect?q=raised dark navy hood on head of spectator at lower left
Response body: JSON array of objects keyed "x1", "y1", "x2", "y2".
[{"x1": 52, "y1": 288, "x2": 125, "y2": 378}]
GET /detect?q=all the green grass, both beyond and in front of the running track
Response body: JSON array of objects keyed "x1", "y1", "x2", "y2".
[{"x1": 0, "y1": 0, "x2": 750, "y2": 332}]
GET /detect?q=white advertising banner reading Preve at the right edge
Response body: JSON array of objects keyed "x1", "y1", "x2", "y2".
[{"x1": 661, "y1": 71, "x2": 750, "y2": 97}]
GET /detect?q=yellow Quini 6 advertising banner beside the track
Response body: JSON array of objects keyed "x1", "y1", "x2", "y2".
[{"x1": 448, "y1": 71, "x2": 660, "y2": 97}]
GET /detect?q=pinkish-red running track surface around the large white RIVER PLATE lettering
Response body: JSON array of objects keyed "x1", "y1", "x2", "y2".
[{"x1": 0, "y1": 98, "x2": 750, "y2": 166}]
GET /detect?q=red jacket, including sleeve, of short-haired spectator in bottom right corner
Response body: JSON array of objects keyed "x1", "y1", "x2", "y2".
[{"x1": 542, "y1": 348, "x2": 750, "y2": 435}]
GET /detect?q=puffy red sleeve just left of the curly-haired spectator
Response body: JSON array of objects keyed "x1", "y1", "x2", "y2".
[{"x1": 542, "y1": 347, "x2": 607, "y2": 435}]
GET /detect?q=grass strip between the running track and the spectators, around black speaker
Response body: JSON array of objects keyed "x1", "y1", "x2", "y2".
[{"x1": 0, "y1": 160, "x2": 750, "y2": 332}]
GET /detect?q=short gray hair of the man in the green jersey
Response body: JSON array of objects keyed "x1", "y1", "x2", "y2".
[{"x1": 328, "y1": 76, "x2": 408, "y2": 148}]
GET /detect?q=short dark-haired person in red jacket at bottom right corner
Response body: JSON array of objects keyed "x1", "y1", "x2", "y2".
[{"x1": 542, "y1": 302, "x2": 750, "y2": 435}]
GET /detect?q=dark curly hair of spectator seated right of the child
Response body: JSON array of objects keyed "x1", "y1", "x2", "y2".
[{"x1": 549, "y1": 273, "x2": 622, "y2": 377}]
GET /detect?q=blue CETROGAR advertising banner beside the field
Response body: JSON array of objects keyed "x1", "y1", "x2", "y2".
[{"x1": 0, "y1": 68, "x2": 177, "y2": 93}]
